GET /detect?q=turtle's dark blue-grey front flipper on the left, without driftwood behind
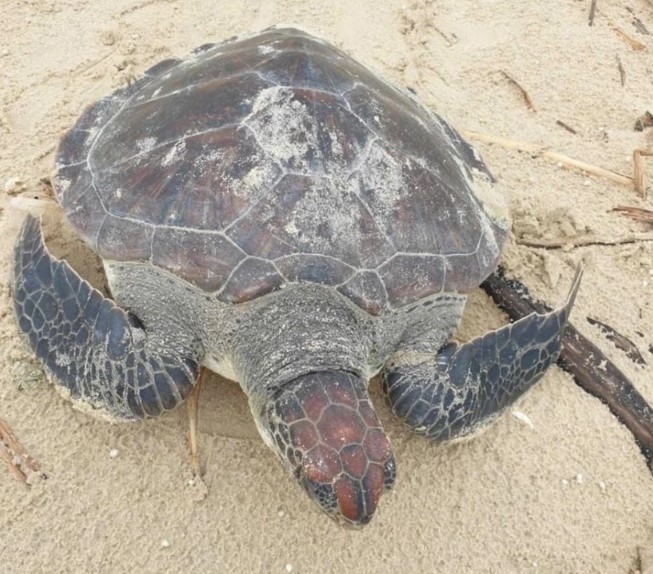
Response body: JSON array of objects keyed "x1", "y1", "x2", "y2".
[{"x1": 13, "y1": 216, "x2": 201, "y2": 419}]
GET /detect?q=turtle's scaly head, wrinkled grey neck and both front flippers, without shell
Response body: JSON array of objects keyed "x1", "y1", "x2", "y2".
[{"x1": 14, "y1": 212, "x2": 580, "y2": 525}]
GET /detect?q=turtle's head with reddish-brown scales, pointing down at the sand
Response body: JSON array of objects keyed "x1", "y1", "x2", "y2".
[{"x1": 260, "y1": 371, "x2": 395, "y2": 526}]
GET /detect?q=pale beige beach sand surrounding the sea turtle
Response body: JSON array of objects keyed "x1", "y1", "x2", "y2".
[{"x1": 0, "y1": 0, "x2": 653, "y2": 574}]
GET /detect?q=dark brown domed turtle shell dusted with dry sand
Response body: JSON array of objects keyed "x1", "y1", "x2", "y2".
[{"x1": 54, "y1": 25, "x2": 507, "y2": 314}]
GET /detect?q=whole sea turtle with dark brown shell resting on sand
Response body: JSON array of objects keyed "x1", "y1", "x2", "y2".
[{"x1": 13, "y1": 28, "x2": 578, "y2": 525}]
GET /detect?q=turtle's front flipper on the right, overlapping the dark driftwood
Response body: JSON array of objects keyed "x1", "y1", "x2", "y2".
[{"x1": 383, "y1": 270, "x2": 582, "y2": 440}]
